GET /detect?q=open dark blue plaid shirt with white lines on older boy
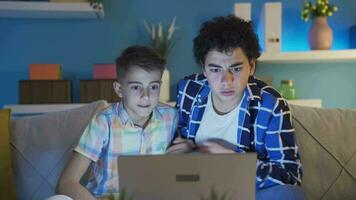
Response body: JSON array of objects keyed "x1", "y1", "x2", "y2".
[{"x1": 177, "y1": 74, "x2": 302, "y2": 189}]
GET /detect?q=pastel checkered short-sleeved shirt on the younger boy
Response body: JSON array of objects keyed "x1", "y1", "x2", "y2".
[{"x1": 75, "y1": 103, "x2": 178, "y2": 197}]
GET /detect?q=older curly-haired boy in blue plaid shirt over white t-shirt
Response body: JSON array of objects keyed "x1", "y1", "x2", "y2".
[{"x1": 168, "y1": 15, "x2": 304, "y2": 199}]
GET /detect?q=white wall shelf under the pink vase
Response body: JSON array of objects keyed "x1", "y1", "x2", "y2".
[{"x1": 258, "y1": 49, "x2": 356, "y2": 64}]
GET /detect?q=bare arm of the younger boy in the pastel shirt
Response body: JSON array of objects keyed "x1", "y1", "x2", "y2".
[{"x1": 56, "y1": 152, "x2": 96, "y2": 200}]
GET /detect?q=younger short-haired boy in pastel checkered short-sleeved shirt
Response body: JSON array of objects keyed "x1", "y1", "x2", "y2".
[{"x1": 57, "y1": 46, "x2": 177, "y2": 200}]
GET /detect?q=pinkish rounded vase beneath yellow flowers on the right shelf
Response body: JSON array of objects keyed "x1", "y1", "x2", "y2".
[{"x1": 309, "y1": 17, "x2": 333, "y2": 50}]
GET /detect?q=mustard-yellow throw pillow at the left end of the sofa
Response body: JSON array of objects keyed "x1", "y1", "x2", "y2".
[{"x1": 0, "y1": 109, "x2": 16, "y2": 200}]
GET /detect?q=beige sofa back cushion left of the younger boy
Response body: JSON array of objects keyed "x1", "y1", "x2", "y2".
[{"x1": 11, "y1": 101, "x2": 107, "y2": 199}]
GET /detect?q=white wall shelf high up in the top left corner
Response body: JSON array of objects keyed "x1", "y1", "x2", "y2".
[{"x1": 0, "y1": 1, "x2": 104, "y2": 19}]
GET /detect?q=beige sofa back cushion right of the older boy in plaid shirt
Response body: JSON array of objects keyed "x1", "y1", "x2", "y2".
[{"x1": 291, "y1": 105, "x2": 356, "y2": 199}]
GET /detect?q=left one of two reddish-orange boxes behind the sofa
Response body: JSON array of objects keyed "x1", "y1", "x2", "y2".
[{"x1": 30, "y1": 64, "x2": 62, "y2": 80}]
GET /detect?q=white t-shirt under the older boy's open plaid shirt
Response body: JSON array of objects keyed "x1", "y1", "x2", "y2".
[{"x1": 195, "y1": 92, "x2": 242, "y2": 145}]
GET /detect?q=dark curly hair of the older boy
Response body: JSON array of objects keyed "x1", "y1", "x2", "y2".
[{"x1": 193, "y1": 15, "x2": 261, "y2": 64}]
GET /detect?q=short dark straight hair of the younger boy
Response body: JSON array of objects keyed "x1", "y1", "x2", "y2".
[{"x1": 116, "y1": 45, "x2": 166, "y2": 80}]
